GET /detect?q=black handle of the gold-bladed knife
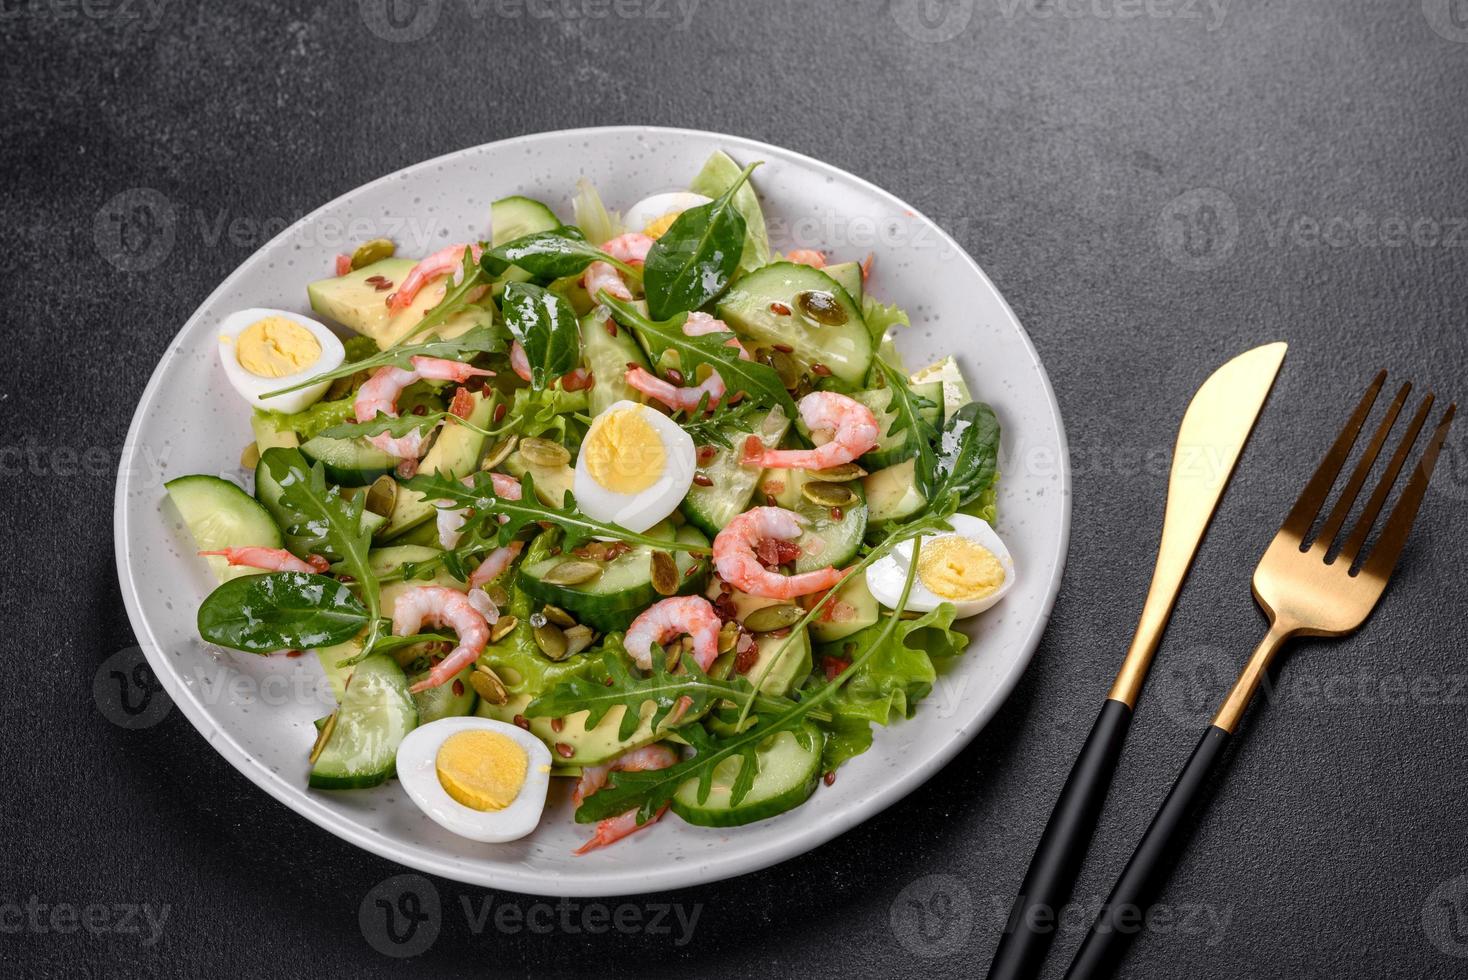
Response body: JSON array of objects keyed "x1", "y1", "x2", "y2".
[{"x1": 989, "y1": 698, "x2": 1132, "y2": 980}]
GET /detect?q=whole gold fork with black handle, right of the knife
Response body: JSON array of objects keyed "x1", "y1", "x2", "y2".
[{"x1": 1066, "y1": 371, "x2": 1456, "y2": 979}]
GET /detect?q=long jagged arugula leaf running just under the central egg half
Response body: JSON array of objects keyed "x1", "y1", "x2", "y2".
[{"x1": 404, "y1": 471, "x2": 711, "y2": 555}]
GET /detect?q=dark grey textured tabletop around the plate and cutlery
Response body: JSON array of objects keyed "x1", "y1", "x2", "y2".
[{"x1": 0, "y1": 0, "x2": 1468, "y2": 977}]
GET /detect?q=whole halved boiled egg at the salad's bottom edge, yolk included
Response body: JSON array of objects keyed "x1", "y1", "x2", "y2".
[{"x1": 398, "y1": 717, "x2": 551, "y2": 844}]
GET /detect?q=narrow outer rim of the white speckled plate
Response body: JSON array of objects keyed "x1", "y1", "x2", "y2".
[{"x1": 113, "y1": 125, "x2": 1073, "y2": 898}]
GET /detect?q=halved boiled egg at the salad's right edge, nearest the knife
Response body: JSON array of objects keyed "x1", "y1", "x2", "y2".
[{"x1": 866, "y1": 513, "x2": 1014, "y2": 619}]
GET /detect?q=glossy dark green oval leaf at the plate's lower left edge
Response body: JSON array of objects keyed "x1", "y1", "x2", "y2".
[{"x1": 198, "y1": 572, "x2": 368, "y2": 653}]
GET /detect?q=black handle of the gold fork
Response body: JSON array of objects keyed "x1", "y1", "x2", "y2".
[{"x1": 1066, "y1": 725, "x2": 1229, "y2": 980}]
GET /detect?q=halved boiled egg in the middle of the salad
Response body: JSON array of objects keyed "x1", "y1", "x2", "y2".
[{"x1": 571, "y1": 401, "x2": 697, "y2": 531}]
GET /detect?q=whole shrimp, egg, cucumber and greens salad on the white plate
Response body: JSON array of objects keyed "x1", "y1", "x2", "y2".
[{"x1": 167, "y1": 153, "x2": 1014, "y2": 854}]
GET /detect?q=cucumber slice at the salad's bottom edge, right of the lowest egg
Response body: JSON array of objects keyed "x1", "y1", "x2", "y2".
[{"x1": 672, "y1": 725, "x2": 824, "y2": 827}]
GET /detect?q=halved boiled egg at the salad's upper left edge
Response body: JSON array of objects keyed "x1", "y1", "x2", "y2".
[{"x1": 219, "y1": 308, "x2": 346, "y2": 412}]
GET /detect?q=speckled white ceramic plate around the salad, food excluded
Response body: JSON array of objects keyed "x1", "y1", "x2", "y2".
[{"x1": 115, "y1": 126, "x2": 1070, "y2": 896}]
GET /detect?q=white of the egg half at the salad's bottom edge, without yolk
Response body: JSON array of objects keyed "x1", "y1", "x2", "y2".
[{"x1": 398, "y1": 716, "x2": 551, "y2": 844}]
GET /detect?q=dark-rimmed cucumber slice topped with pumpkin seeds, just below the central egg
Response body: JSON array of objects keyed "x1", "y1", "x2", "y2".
[{"x1": 518, "y1": 522, "x2": 709, "y2": 632}]
